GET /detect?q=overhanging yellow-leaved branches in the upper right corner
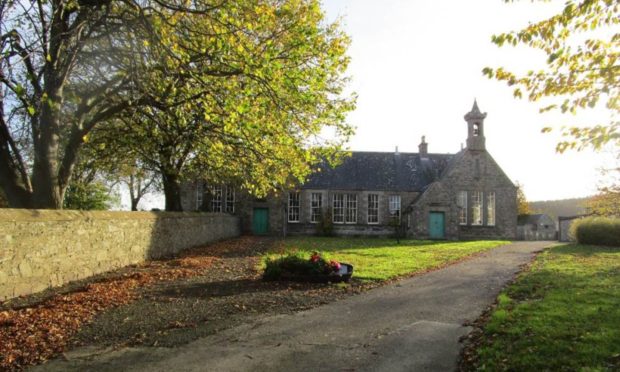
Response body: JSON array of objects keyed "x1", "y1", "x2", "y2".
[{"x1": 483, "y1": 0, "x2": 620, "y2": 152}]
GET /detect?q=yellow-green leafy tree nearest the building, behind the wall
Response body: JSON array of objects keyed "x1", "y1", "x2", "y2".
[{"x1": 85, "y1": 1, "x2": 354, "y2": 210}]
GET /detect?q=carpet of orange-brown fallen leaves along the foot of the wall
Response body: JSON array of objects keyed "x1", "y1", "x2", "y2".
[{"x1": 0, "y1": 237, "x2": 260, "y2": 370}]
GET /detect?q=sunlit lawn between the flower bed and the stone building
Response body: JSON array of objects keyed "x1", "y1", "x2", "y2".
[{"x1": 270, "y1": 237, "x2": 509, "y2": 281}]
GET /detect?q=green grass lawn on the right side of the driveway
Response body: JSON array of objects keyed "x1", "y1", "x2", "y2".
[{"x1": 476, "y1": 245, "x2": 620, "y2": 371}]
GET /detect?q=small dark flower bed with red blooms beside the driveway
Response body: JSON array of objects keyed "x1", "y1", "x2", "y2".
[{"x1": 263, "y1": 252, "x2": 353, "y2": 283}]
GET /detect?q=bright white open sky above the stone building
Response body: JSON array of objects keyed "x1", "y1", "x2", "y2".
[{"x1": 323, "y1": 0, "x2": 610, "y2": 201}]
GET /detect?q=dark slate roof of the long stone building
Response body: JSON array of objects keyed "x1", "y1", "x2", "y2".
[{"x1": 302, "y1": 151, "x2": 455, "y2": 191}]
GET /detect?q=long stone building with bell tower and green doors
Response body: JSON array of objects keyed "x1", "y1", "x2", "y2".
[{"x1": 182, "y1": 101, "x2": 517, "y2": 239}]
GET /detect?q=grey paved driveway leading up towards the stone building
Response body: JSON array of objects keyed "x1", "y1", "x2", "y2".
[{"x1": 36, "y1": 242, "x2": 552, "y2": 372}]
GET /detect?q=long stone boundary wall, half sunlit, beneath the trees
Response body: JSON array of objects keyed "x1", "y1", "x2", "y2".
[{"x1": 0, "y1": 209, "x2": 240, "y2": 300}]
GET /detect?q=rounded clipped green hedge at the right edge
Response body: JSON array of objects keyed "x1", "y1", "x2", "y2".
[{"x1": 570, "y1": 217, "x2": 620, "y2": 247}]
